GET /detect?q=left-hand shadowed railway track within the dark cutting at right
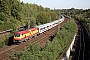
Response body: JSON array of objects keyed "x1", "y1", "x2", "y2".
[{"x1": 78, "y1": 23, "x2": 85, "y2": 60}]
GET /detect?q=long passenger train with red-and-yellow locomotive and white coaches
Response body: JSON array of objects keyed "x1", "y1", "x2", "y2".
[{"x1": 13, "y1": 16, "x2": 65, "y2": 43}]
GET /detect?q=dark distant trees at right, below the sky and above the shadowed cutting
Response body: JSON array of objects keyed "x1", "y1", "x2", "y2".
[{"x1": 57, "y1": 8, "x2": 90, "y2": 32}]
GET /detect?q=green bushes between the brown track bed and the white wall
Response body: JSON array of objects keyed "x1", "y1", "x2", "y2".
[{"x1": 10, "y1": 19, "x2": 76, "y2": 60}]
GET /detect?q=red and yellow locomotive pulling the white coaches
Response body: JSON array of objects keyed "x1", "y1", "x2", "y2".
[{"x1": 14, "y1": 28, "x2": 38, "y2": 42}]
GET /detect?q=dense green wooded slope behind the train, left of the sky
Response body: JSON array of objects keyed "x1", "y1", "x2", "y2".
[{"x1": 0, "y1": 0, "x2": 57, "y2": 31}]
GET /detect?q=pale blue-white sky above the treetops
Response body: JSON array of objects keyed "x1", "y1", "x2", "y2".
[{"x1": 20, "y1": 0, "x2": 90, "y2": 9}]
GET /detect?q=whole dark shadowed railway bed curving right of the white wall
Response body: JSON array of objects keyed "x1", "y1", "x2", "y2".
[{"x1": 72, "y1": 20, "x2": 90, "y2": 60}]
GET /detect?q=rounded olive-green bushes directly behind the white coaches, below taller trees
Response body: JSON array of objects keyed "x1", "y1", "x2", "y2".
[{"x1": 36, "y1": 12, "x2": 56, "y2": 25}]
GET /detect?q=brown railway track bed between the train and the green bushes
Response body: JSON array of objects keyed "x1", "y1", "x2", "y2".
[{"x1": 0, "y1": 19, "x2": 67, "y2": 60}]
